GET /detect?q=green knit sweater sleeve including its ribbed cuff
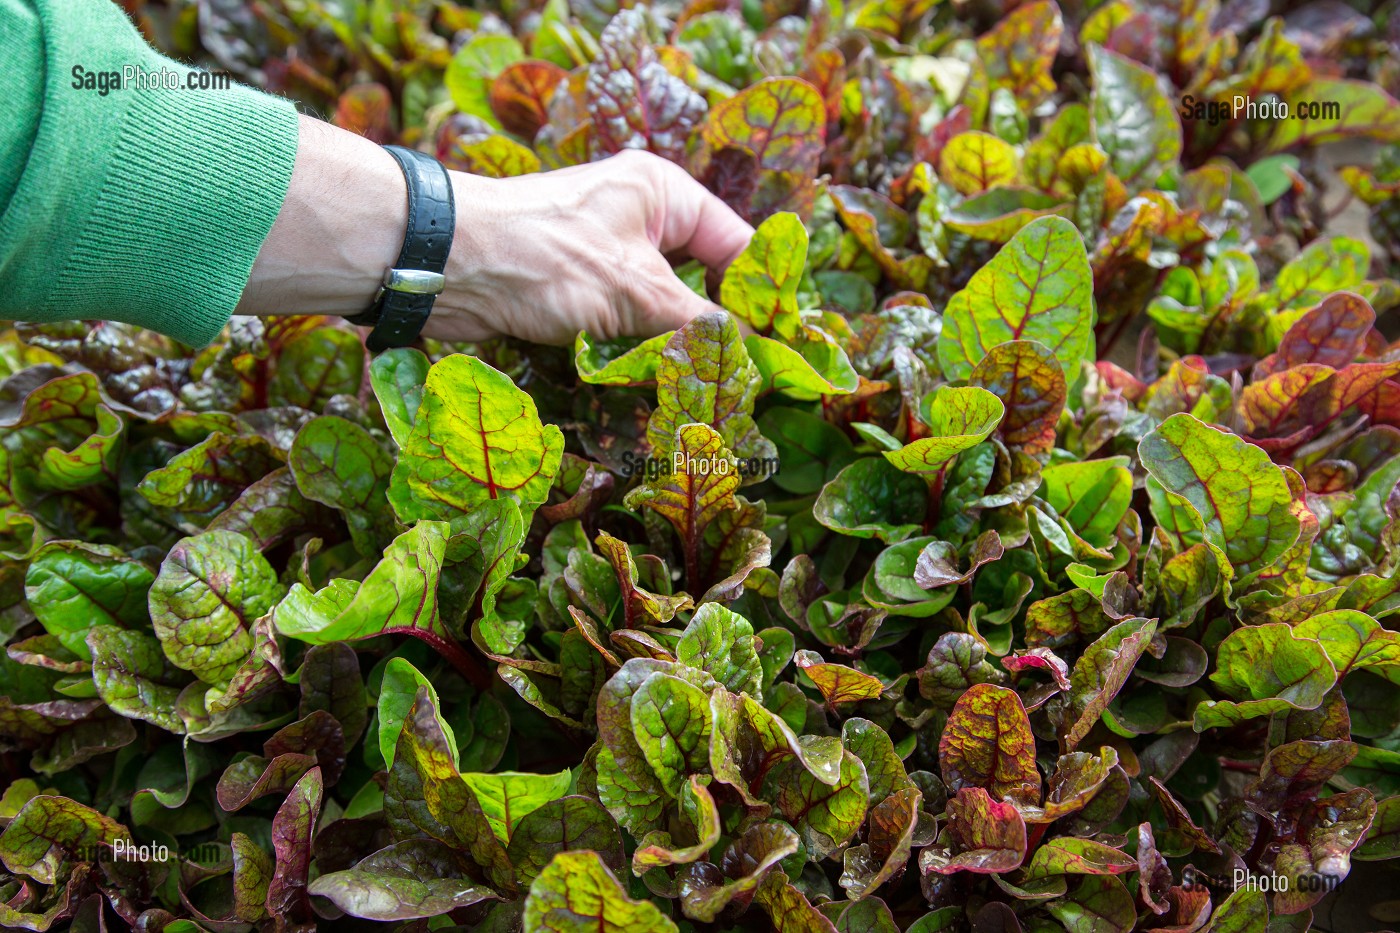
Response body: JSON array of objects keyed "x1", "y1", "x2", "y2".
[{"x1": 0, "y1": 0, "x2": 297, "y2": 346}]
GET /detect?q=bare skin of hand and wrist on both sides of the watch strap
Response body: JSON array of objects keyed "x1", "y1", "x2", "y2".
[{"x1": 238, "y1": 116, "x2": 753, "y2": 343}]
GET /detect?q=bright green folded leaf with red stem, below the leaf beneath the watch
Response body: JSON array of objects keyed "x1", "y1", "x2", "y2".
[{"x1": 273, "y1": 521, "x2": 451, "y2": 644}]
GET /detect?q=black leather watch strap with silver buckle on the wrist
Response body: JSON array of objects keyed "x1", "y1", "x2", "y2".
[{"x1": 346, "y1": 146, "x2": 456, "y2": 353}]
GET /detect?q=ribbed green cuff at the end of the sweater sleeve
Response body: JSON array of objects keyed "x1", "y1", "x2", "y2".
[{"x1": 50, "y1": 77, "x2": 298, "y2": 347}]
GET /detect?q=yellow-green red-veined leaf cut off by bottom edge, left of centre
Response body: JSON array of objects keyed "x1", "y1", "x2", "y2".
[{"x1": 525, "y1": 852, "x2": 676, "y2": 933}]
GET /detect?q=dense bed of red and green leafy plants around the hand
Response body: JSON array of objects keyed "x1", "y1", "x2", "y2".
[{"x1": 0, "y1": 0, "x2": 1400, "y2": 933}]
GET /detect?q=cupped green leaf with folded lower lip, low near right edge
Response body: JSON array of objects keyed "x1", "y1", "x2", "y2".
[{"x1": 1196, "y1": 622, "x2": 1337, "y2": 733}]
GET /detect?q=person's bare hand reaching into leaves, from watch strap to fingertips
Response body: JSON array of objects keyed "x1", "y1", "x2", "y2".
[{"x1": 424, "y1": 150, "x2": 753, "y2": 343}]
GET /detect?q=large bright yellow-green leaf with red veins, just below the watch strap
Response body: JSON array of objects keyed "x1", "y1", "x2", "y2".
[{"x1": 389, "y1": 353, "x2": 564, "y2": 525}]
